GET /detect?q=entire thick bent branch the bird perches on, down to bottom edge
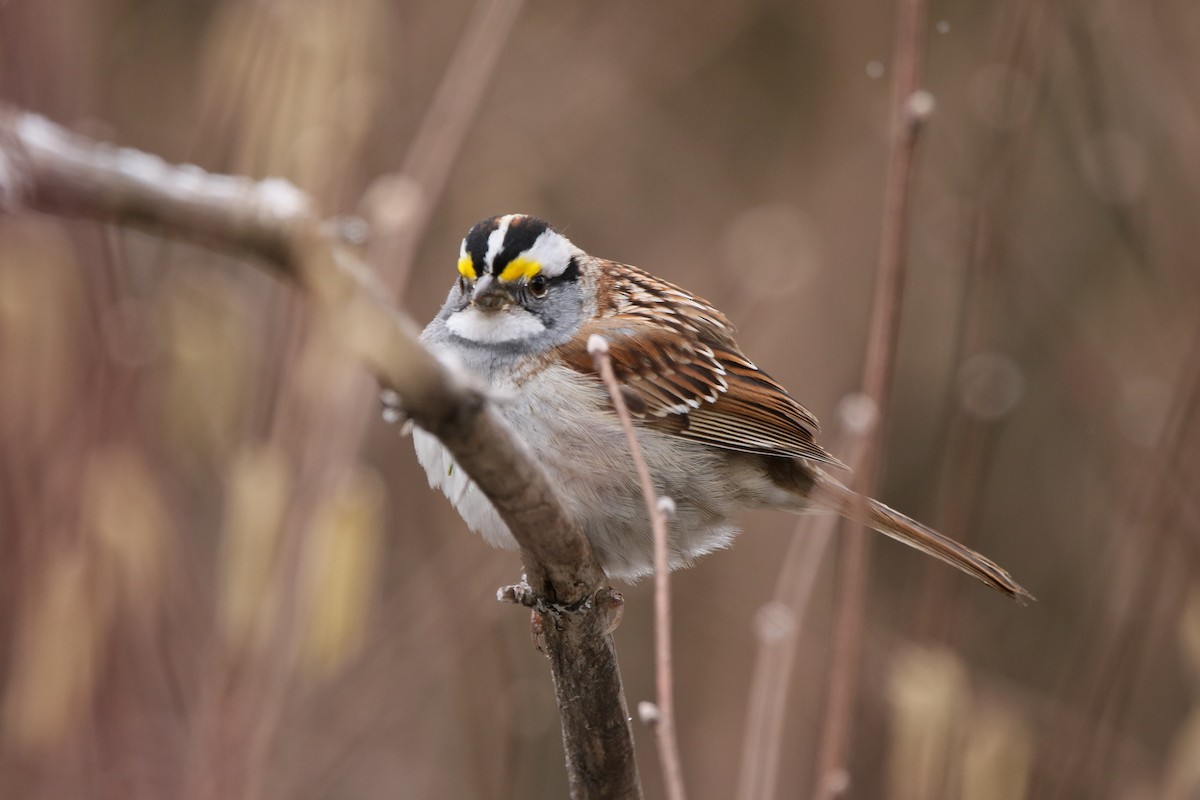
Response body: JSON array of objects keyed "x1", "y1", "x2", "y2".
[{"x1": 0, "y1": 107, "x2": 641, "y2": 800}]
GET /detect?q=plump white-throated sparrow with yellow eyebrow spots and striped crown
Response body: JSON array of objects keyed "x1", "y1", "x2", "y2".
[{"x1": 413, "y1": 213, "x2": 1032, "y2": 602}]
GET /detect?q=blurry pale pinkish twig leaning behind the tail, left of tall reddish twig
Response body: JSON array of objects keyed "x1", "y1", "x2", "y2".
[{"x1": 737, "y1": 393, "x2": 876, "y2": 800}]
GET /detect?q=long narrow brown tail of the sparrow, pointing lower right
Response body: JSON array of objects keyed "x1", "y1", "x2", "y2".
[{"x1": 816, "y1": 474, "x2": 1034, "y2": 604}]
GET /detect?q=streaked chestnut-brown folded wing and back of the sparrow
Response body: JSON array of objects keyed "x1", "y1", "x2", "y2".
[{"x1": 563, "y1": 261, "x2": 840, "y2": 465}]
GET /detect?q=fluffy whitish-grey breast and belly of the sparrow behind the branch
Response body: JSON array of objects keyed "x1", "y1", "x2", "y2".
[{"x1": 413, "y1": 367, "x2": 782, "y2": 581}]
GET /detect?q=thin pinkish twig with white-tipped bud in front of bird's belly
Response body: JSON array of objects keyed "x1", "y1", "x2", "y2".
[{"x1": 588, "y1": 333, "x2": 685, "y2": 800}]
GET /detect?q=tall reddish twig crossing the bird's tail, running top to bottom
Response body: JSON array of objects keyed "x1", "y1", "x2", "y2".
[{"x1": 814, "y1": 0, "x2": 932, "y2": 798}]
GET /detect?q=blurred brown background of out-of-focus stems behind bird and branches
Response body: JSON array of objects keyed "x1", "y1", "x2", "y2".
[{"x1": 0, "y1": 0, "x2": 1200, "y2": 800}]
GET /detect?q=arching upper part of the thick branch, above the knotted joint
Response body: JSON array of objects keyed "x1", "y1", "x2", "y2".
[{"x1": 0, "y1": 106, "x2": 602, "y2": 603}]
